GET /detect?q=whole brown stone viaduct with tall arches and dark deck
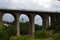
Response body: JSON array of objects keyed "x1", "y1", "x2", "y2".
[{"x1": 0, "y1": 9, "x2": 59, "y2": 36}]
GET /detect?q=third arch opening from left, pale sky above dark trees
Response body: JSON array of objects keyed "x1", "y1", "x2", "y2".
[{"x1": 34, "y1": 15, "x2": 43, "y2": 31}]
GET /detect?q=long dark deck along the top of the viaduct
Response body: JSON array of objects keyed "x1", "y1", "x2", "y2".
[{"x1": 0, "y1": 9, "x2": 60, "y2": 14}]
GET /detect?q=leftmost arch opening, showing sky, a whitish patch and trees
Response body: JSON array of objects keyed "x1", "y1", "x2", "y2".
[{"x1": 2, "y1": 13, "x2": 16, "y2": 36}]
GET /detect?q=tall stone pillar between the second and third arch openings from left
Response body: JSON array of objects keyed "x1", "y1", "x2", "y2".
[{"x1": 28, "y1": 16, "x2": 35, "y2": 37}]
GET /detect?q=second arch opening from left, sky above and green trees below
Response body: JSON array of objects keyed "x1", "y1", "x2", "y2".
[{"x1": 19, "y1": 14, "x2": 29, "y2": 35}]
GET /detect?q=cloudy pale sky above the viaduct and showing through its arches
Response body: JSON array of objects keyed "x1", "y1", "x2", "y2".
[{"x1": 0, "y1": 0, "x2": 60, "y2": 24}]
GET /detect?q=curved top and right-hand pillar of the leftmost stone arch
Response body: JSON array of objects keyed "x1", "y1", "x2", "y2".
[{"x1": 3, "y1": 11, "x2": 20, "y2": 36}]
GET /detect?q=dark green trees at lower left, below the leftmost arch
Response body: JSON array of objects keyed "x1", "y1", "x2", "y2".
[{"x1": 0, "y1": 24, "x2": 16, "y2": 40}]
